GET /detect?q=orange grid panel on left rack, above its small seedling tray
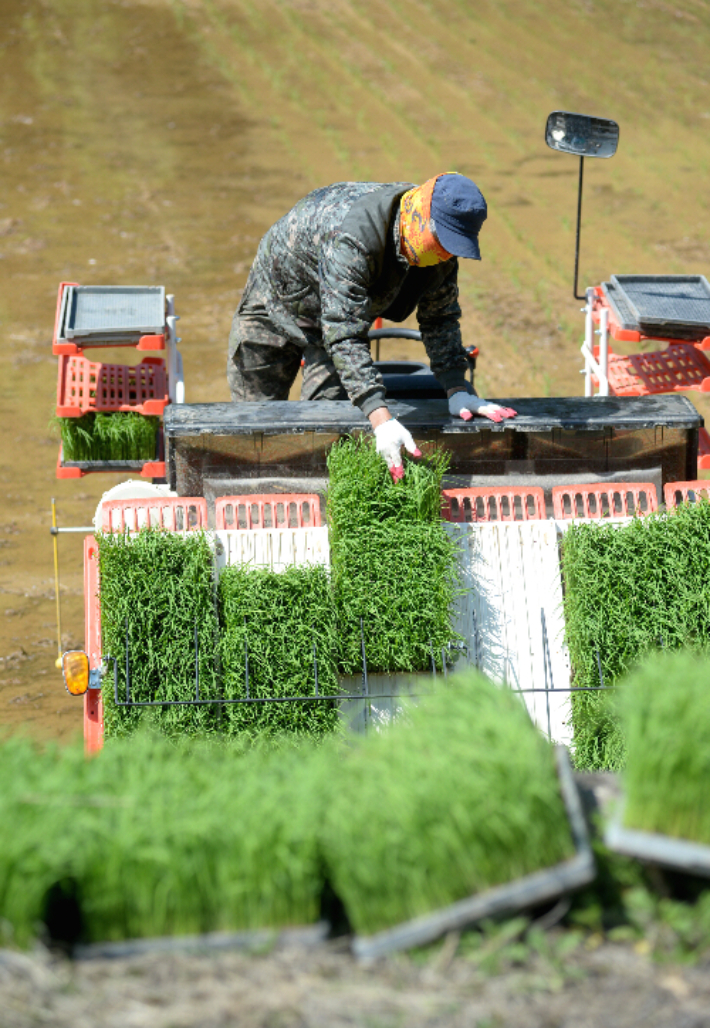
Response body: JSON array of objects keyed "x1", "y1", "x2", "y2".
[{"x1": 57, "y1": 356, "x2": 170, "y2": 417}]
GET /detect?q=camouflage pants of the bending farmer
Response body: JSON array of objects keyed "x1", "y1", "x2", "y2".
[{"x1": 227, "y1": 276, "x2": 347, "y2": 403}]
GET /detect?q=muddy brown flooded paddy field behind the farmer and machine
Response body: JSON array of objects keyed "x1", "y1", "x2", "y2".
[{"x1": 0, "y1": 0, "x2": 710, "y2": 740}]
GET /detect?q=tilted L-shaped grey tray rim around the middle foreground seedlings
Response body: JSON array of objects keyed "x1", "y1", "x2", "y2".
[{"x1": 352, "y1": 746, "x2": 596, "y2": 960}]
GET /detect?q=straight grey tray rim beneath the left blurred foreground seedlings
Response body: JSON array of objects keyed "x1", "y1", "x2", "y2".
[{"x1": 72, "y1": 921, "x2": 330, "y2": 960}]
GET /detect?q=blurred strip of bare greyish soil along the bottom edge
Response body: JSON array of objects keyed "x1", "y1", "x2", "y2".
[{"x1": 0, "y1": 939, "x2": 710, "y2": 1028}]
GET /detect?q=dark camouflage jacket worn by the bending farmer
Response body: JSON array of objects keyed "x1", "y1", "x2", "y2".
[{"x1": 242, "y1": 182, "x2": 468, "y2": 414}]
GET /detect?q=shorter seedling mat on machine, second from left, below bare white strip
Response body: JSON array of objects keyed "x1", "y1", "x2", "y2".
[{"x1": 219, "y1": 565, "x2": 339, "y2": 736}]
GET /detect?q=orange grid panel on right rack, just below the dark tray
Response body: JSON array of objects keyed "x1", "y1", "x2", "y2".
[{"x1": 595, "y1": 342, "x2": 710, "y2": 396}]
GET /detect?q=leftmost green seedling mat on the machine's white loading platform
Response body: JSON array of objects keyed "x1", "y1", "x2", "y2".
[{"x1": 98, "y1": 528, "x2": 222, "y2": 738}]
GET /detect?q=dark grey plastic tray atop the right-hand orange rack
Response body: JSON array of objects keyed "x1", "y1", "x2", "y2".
[{"x1": 604, "y1": 274, "x2": 710, "y2": 338}]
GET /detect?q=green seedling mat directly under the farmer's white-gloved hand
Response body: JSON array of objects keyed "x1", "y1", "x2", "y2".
[{"x1": 328, "y1": 438, "x2": 457, "y2": 674}]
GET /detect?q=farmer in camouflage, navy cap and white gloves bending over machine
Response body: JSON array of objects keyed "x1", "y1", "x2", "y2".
[{"x1": 227, "y1": 174, "x2": 515, "y2": 479}]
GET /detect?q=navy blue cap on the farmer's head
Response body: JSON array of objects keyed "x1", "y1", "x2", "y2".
[{"x1": 432, "y1": 173, "x2": 488, "y2": 260}]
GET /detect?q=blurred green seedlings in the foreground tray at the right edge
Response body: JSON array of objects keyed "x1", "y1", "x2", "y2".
[{"x1": 622, "y1": 652, "x2": 710, "y2": 845}]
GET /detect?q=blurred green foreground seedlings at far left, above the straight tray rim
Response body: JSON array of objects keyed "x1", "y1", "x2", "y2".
[{"x1": 0, "y1": 733, "x2": 323, "y2": 945}]
